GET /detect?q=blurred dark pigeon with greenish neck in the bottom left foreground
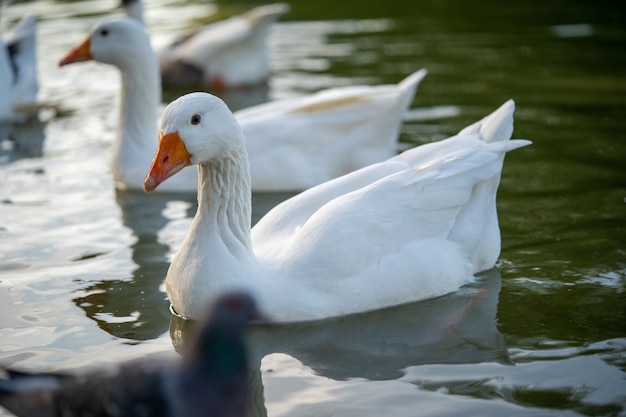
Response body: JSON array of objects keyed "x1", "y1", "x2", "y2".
[{"x1": 0, "y1": 293, "x2": 260, "y2": 417}]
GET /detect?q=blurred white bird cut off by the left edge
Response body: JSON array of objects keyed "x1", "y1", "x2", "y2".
[{"x1": 0, "y1": 15, "x2": 39, "y2": 121}]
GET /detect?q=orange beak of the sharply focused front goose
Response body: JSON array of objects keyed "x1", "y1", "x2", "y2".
[{"x1": 143, "y1": 132, "x2": 191, "y2": 193}]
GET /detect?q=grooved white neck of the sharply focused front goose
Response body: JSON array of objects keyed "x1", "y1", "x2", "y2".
[{"x1": 165, "y1": 146, "x2": 258, "y2": 308}]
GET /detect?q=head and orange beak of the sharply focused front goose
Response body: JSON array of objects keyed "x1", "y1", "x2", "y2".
[{"x1": 144, "y1": 93, "x2": 247, "y2": 192}]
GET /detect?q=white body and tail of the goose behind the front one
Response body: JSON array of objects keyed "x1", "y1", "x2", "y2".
[{"x1": 235, "y1": 69, "x2": 426, "y2": 191}]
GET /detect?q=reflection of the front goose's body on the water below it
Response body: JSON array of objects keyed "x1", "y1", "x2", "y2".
[{"x1": 170, "y1": 269, "x2": 510, "y2": 415}]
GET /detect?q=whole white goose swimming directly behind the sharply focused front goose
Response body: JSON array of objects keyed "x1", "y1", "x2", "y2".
[{"x1": 60, "y1": 18, "x2": 426, "y2": 192}]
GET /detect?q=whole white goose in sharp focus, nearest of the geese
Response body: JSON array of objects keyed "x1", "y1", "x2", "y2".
[{"x1": 144, "y1": 93, "x2": 530, "y2": 322}]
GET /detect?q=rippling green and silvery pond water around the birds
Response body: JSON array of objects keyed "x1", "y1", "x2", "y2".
[{"x1": 0, "y1": 0, "x2": 626, "y2": 416}]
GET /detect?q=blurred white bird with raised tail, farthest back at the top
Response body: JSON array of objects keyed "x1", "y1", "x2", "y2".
[{"x1": 122, "y1": 0, "x2": 289, "y2": 89}]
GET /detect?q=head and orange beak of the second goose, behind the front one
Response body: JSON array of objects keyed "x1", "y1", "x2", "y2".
[{"x1": 59, "y1": 18, "x2": 152, "y2": 68}]
